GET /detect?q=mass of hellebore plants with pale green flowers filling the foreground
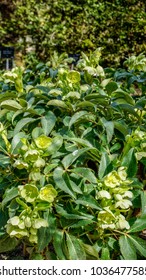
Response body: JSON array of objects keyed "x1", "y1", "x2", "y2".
[{"x1": 0, "y1": 50, "x2": 146, "y2": 260}]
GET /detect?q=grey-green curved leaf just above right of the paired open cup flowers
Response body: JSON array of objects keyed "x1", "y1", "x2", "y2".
[{"x1": 53, "y1": 167, "x2": 75, "y2": 198}]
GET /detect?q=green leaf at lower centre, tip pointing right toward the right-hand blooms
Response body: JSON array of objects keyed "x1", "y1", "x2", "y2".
[{"x1": 75, "y1": 195, "x2": 102, "y2": 210}]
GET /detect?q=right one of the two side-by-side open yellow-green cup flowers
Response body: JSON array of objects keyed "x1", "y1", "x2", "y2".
[{"x1": 39, "y1": 185, "x2": 57, "y2": 203}]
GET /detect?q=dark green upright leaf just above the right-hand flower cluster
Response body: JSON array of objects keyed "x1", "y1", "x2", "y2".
[{"x1": 121, "y1": 148, "x2": 137, "y2": 177}]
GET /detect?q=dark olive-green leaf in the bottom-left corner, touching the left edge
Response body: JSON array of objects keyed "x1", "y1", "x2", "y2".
[{"x1": 0, "y1": 235, "x2": 19, "y2": 253}]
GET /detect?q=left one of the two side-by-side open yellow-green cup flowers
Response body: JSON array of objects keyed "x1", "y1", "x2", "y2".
[{"x1": 18, "y1": 184, "x2": 39, "y2": 202}]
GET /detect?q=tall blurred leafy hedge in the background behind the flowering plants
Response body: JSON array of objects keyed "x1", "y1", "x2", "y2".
[{"x1": 0, "y1": 0, "x2": 146, "y2": 66}]
